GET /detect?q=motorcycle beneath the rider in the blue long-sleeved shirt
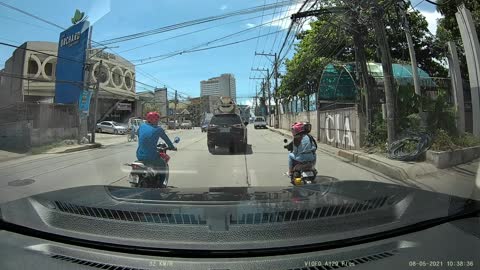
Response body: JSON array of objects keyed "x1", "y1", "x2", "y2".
[{"x1": 125, "y1": 137, "x2": 180, "y2": 188}]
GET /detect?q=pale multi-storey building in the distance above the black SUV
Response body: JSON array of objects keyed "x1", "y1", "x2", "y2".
[{"x1": 200, "y1": 74, "x2": 237, "y2": 101}]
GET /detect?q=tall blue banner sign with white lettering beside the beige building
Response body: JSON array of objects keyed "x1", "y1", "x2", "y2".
[{"x1": 55, "y1": 21, "x2": 90, "y2": 104}]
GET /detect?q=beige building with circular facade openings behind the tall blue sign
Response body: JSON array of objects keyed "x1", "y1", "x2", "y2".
[{"x1": 0, "y1": 41, "x2": 135, "y2": 121}]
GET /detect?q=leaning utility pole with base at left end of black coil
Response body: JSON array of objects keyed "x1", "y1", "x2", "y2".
[{"x1": 372, "y1": 3, "x2": 395, "y2": 145}]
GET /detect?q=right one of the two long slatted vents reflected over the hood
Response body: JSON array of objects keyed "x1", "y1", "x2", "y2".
[{"x1": 230, "y1": 196, "x2": 393, "y2": 224}]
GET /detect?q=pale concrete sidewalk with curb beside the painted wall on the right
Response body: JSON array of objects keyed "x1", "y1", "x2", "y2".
[{"x1": 268, "y1": 127, "x2": 480, "y2": 197}]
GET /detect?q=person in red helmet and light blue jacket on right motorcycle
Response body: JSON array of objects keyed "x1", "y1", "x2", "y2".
[{"x1": 288, "y1": 122, "x2": 317, "y2": 176}]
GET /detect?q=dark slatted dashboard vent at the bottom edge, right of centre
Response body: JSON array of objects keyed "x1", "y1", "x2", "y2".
[{"x1": 288, "y1": 250, "x2": 397, "y2": 270}]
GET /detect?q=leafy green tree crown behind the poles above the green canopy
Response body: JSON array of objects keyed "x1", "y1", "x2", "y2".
[{"x1": 279, "y1": 0, "x2": 446, "y2": 98}]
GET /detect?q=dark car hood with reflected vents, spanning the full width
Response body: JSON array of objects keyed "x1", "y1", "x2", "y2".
[{"x1": 0, "y1": 181, "x2": 479, "y2": 251}]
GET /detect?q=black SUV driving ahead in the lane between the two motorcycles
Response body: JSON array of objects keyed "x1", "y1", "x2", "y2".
[{"x1": 207, "y1": 113, "x2": 248, "y2": 153}]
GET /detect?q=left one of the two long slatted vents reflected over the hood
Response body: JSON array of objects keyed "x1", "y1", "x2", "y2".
[{"x1": 55, "y1": 201, "x2": 207, "y2": 225}]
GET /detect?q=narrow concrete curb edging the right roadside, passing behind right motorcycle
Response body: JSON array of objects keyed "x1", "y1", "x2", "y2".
[{"x1": 268, "y1": 127, "x2": 411, "y2": 181}]
